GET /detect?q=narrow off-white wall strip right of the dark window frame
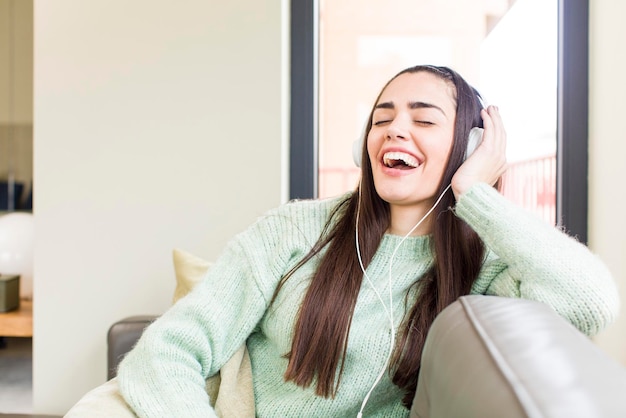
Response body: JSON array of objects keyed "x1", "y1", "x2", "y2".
[{"x1": 589, "y1": 0, "x2": 626, "y2": 365}]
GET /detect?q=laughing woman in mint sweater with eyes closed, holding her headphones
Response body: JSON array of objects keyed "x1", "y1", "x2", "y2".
[{"x1": 118, "y1": 66, "x2": 618, "y2": 417}]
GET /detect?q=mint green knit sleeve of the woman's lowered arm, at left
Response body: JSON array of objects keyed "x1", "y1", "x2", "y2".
[{"x1": 118, "y1": 202, "x2": 316, "y2": 418}]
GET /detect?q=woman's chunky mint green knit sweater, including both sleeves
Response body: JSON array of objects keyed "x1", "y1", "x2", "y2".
[{"x1": 118, "y1": 184, "x2": 619, "y2": 418}]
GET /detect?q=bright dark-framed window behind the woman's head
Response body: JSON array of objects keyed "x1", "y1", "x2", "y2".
[{"x1": 291, "y1": 0, "x2": 588, "y2": 241}]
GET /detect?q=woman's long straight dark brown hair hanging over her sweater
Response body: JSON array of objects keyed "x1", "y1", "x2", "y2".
[{"x1": 274, "y1": 66, "x2": 484, "y2": 407}]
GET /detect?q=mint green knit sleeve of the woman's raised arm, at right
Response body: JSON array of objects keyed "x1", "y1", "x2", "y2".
[{"x1": 455, "y1": 184, "x2": 619, "y2": 336}]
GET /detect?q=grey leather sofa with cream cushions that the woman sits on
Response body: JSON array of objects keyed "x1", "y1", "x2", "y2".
[{"x1": 65, "y1": 250, "x2": 626, "y2": 418}]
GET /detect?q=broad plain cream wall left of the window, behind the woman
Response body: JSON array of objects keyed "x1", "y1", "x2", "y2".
[{"x1": 33, "y1": 0, "x2": 288, "y2": 414}]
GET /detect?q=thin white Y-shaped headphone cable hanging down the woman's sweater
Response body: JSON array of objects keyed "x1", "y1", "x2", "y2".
[{"x1": 354, "y1": 184, "x2": 451, "y2": 418}]
